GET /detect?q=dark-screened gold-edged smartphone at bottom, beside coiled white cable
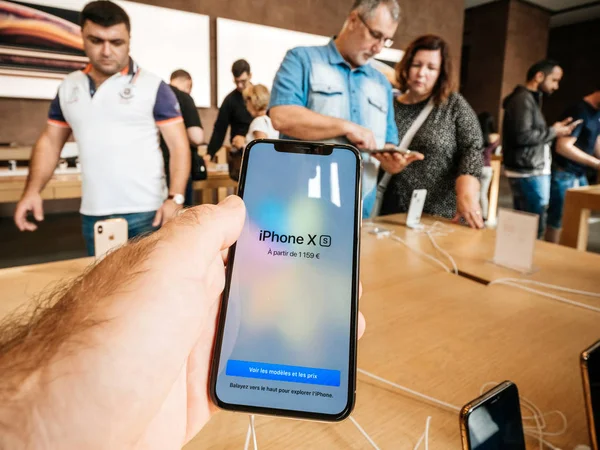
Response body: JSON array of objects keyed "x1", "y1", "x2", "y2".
[{"x1": 460, "y1": 381, "x2": 525, "y2": 450}]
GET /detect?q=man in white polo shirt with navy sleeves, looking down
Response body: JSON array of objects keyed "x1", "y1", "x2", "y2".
[{"x1": 14, "y1": 1, "x2": 190, "y2": 255}]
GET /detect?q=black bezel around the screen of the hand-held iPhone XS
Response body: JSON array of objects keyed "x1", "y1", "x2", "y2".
[{"x1": 209, "y1": 139, "x2": 362, "y2": 422}]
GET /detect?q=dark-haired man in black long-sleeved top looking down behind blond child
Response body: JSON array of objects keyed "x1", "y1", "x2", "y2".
[{"x1": 206, "y1": 59, "x2": 252, "y2": 159}]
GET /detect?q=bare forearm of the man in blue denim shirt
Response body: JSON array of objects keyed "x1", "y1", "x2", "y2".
[{"x1": 270, "y1": 105, "x2": 348, "y2": 141}]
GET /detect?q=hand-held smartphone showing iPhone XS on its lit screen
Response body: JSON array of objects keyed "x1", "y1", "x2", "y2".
[{"x1": 209, "y1": 140, "x2": 362, "y2": 421}]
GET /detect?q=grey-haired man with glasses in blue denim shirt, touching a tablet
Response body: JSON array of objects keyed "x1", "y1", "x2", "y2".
[{"x1": 269, "y1": 0, "x2": 418, "y2": 217}]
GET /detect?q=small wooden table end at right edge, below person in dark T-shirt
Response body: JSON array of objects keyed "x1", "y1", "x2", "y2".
[{"x1": 560, "y1": 185, "x2": 600, "y2": 251}]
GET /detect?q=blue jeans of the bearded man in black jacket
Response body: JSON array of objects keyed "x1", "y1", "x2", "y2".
[{"x1": 508, "y1": 175, "x2": 550, "y2": 239}]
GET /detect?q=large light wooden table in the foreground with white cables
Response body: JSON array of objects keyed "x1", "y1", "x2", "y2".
[{"x1": 0, "y1": 227, "x2": 599, "y2": 450}]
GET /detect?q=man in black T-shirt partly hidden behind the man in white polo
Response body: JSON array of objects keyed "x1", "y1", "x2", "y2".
[{"x1": 160, "y1": 69, "x2": 206, "y2": 206}]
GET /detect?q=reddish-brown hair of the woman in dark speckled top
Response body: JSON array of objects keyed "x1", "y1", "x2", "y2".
[{"x1": 396, "y1": 34, "x2": 455, "y2": 105}]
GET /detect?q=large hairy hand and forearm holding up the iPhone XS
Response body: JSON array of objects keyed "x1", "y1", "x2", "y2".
[{"x1": 0, "y1": 196, "x2": 365, "y2": 449}]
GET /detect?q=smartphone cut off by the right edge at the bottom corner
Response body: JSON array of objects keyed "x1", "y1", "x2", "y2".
[{"x1": 581, "y1": 341, "x2": 600, "y2": 450}]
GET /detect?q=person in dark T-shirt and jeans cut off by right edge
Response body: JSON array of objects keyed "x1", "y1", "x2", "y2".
[{"x1": 546, "y1": 88, "x2": 600, "y2": 243}]
